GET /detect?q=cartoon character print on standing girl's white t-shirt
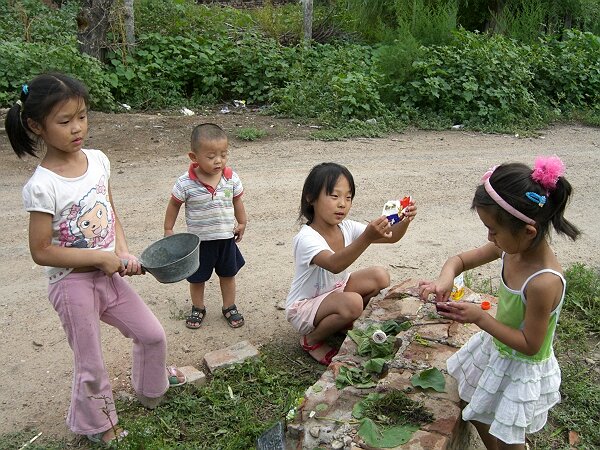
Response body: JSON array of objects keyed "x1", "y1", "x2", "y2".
[{"x1": 59, "y1": 176, "x2": 115, "y2": 248}]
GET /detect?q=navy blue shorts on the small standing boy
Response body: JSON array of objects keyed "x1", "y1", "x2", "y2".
[{"x1": 187, "y1": 238, "x2": 246, "y2": 283}]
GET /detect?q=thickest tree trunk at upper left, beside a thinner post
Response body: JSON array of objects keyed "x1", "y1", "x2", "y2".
[{"x1": 77, "y1": 0, "x2": 113, "y2": 61}]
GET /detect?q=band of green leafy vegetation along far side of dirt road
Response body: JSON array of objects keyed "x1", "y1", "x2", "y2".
[{"x1": 0, "y1": 0, "x2": 600, "y2": 130}]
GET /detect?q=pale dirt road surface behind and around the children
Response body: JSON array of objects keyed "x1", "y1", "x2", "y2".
[{"x1": 0, "y1": 107, "x2": 600, "y2": 444}]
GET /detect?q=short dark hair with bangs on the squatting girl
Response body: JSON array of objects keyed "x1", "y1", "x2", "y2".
[{"x1": 298, "y1": 163, "x2": 356, "y2": 225}]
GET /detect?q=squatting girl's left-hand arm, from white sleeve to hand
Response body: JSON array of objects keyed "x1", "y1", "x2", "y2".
[{"x1": 312, "y1": 216, "x2": 391, "y2": 273}]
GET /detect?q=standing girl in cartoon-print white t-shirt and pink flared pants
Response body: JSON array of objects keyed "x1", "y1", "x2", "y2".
[{"x1": 5, "y1": 73, "x2": 185, "y2": 444}]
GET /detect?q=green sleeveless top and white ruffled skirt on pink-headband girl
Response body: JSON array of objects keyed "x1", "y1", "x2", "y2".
[{"x1": 447, "y1": 255, "x2": 566, "y2": 444}]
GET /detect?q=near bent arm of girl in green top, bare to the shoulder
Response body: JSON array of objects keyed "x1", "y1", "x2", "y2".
[{"x1": 438, "y1": 274, "x2": 563, "y2": 356}]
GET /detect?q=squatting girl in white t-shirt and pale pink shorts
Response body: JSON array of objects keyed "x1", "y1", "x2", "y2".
[{"x1": 286, "y1": 163, "x2": 417, "y2": 365}]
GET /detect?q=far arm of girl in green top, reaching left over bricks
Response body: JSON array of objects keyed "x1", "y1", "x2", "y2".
[{"x1": 419, "y1": 242, "x2": 502, "y2": 302}]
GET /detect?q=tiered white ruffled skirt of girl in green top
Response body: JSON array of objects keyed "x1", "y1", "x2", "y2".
[{"x1": 447, "y1": 331, "x2": 560, "y2": 444}]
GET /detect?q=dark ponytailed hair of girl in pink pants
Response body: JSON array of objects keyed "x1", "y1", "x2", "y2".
[{"x1": 4, "y1": 73, "x2": 89, "y2": 158}]
